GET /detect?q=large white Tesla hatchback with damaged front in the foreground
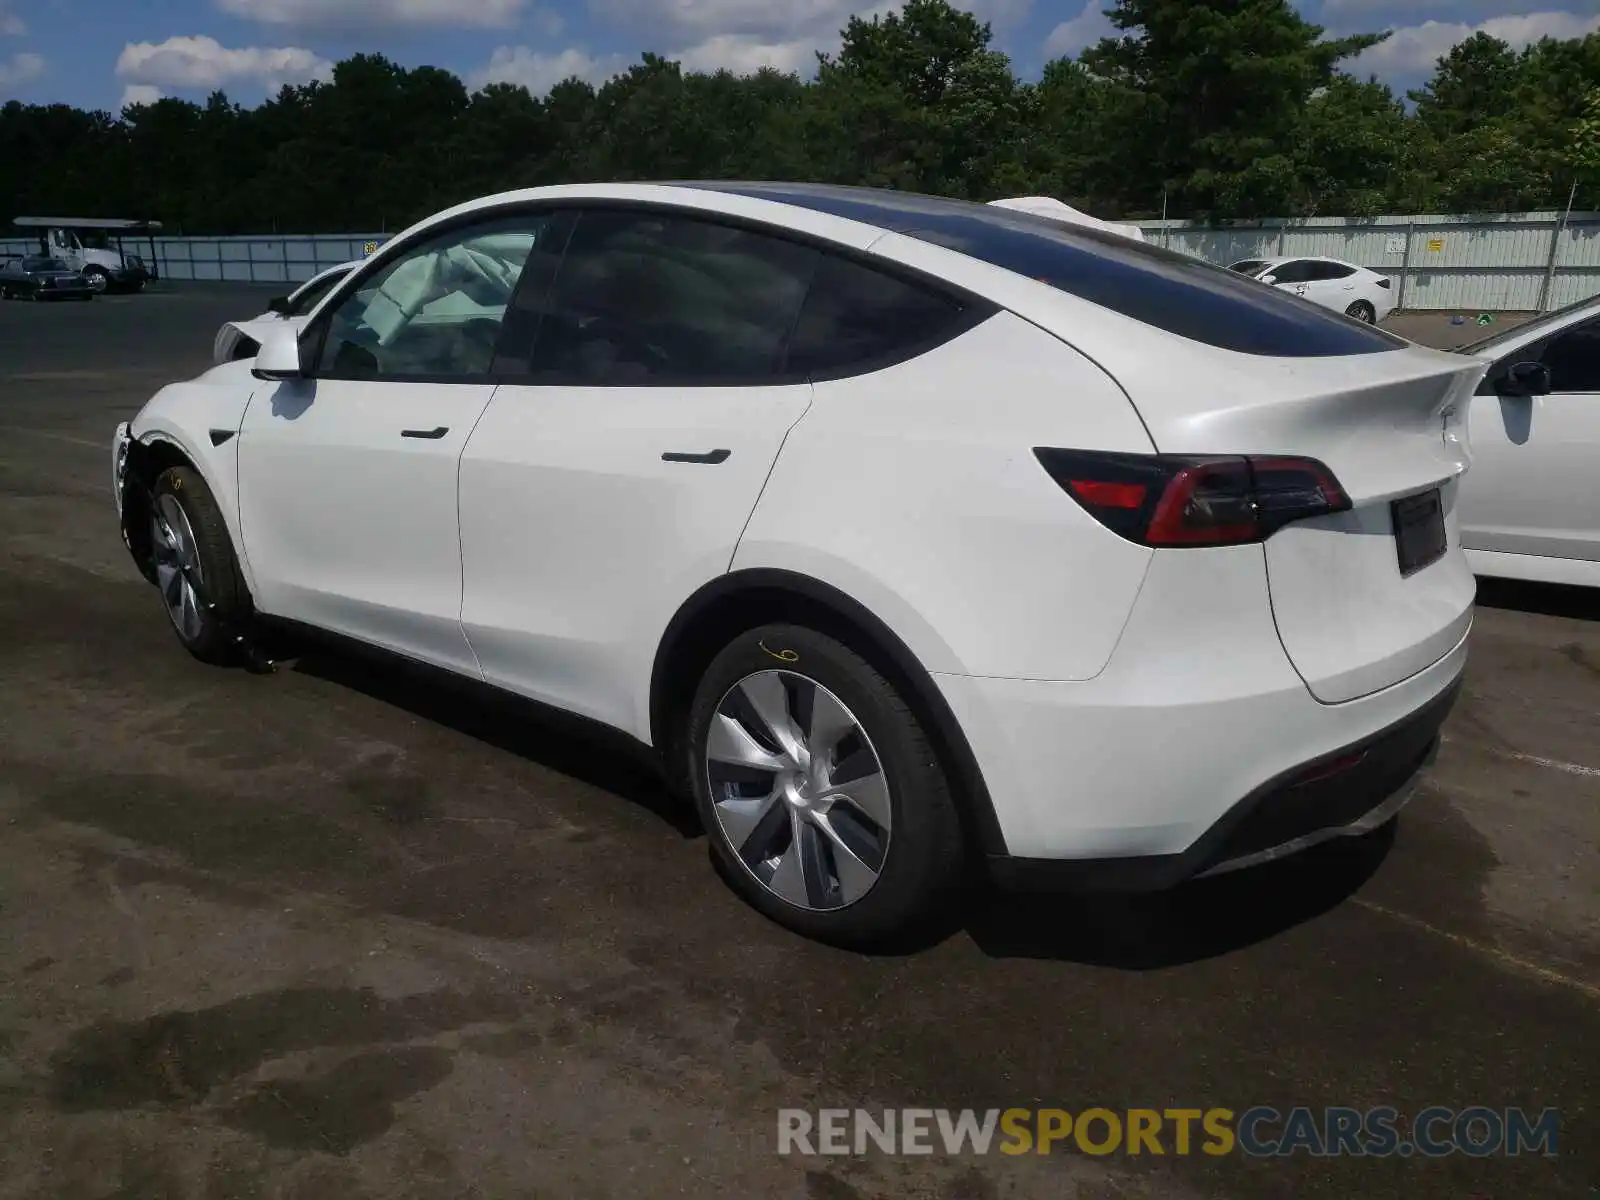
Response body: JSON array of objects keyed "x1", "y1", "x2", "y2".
[{"x1": 114, "y1": 182, "x2": 1486, "y2": 944}]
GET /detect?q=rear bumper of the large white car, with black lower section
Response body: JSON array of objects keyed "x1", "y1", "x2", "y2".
[{"x1": 934, "y1": 546, "x2": 1470, "y2": 886}]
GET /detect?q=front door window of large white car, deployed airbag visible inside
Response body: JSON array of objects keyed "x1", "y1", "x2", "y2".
[{"x1": 317, "y1": 214, "x2": 549, "y2": 379}]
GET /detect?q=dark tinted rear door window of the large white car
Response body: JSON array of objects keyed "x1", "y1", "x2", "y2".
[{"x1": 531, "y1": 210, "x2": 818, "y2": 386}]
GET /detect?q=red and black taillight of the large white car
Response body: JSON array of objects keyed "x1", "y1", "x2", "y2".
[{"x1": 1034, "y1": 448, "x2": 1350, "y2": 546}]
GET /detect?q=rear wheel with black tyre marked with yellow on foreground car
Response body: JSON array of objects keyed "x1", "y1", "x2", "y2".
[{"x1": 685, "y1": 626, "x2": 965, "y2": 949}]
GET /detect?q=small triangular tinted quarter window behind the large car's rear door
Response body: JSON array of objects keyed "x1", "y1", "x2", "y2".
[{"x1": 789, "y1": 254, "x2": 965, "y2": 378}]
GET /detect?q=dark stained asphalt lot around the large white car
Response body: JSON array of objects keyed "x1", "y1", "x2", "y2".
[{"x1": 0, "y1": 285, "x2": 1600, "y2": 1200}]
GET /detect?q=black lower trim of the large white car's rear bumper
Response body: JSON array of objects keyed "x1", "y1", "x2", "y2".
[{"x1": 989, "y1": 678, "x2": 1461, "y2": 891}]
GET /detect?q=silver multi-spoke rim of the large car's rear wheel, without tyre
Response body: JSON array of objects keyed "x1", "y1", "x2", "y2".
[{"x1": 706, "y1": 670, "x2": 893, "y2": 910}]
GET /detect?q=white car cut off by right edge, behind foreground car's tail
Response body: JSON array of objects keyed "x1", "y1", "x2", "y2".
[{"x1": 1461, "y1": 296, "x2": 1600, "y2": 587}]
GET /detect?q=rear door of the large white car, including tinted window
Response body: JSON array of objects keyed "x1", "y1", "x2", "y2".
[{"x1": 461, "y1": 208, "x2": 818, "y2": 738}]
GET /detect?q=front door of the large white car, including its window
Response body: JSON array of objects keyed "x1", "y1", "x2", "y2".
[{"x1": 238, "y1": 214, "x2": 560, "y2": 675}]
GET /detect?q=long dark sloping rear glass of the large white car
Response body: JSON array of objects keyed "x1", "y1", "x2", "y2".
[{"x1": 698, "y1": 182, "x2": 1408, "y2": 358}]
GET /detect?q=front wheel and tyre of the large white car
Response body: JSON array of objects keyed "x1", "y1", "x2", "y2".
[{"x1": 150, "y1": 467, "x2": 250, "y2": 666}]
